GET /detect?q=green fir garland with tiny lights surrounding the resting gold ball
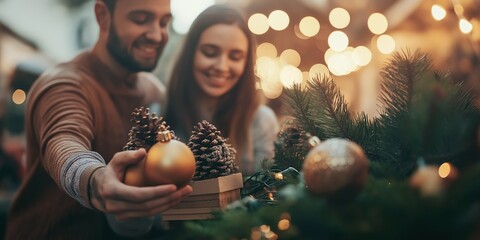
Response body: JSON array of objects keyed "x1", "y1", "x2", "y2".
[{"x1": 161, "y1": 51, "x2": 480, "y2": 239}]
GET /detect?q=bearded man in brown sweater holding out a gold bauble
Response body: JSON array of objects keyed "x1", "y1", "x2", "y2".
[{"x1": 6, "y1": 0, "x2": 192, "y2": 239}]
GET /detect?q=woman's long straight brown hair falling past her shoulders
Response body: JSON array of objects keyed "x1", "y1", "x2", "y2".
[{"x1": 165, "y1": 5, "x2": 260, "y2": 162}]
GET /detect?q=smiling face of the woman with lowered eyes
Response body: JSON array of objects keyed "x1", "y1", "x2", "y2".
[{"x1": 193, "y1": 24, "x2": 249, "y2": 97}]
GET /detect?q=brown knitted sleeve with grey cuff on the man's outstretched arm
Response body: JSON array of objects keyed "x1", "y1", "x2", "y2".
[{"x1": 29, "y1": 79, "x2": 105, "y2": 207}]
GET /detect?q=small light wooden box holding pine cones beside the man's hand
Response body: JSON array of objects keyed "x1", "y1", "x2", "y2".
[{"x1": 162, "y1": 173, "x2": 243, "y2": 221}]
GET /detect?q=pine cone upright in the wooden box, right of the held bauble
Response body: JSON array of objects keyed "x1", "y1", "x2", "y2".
[{"x1": 188, "y1": 120, "x2": 239, "y2": 180}]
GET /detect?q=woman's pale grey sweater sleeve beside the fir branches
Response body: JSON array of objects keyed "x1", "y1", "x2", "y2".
[{"x1": 252, "y1": 105, "x2": 280, "y2": 171}]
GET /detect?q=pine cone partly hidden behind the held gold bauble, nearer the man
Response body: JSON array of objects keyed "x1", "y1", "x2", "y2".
[{"x1": 123, "y1": 107, "x2": 178, "y2": 151}]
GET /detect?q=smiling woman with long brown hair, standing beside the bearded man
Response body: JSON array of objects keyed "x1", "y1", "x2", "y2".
[{"x1": 165, "y1": 5, "x2": 279, "y2": 175}]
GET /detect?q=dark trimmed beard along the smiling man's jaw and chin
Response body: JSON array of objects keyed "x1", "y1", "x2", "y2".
[{"x1": 107, "y1": 24, "x2": 164, "y2": 72}]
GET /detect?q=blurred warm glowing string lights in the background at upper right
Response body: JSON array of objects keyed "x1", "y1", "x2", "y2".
[{"x1": 248, "y1": 0, "x2": 474, "y2": 99}]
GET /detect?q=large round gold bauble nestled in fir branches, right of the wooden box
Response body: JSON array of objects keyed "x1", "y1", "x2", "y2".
[{"x1": 302, "y1": 138, "x2": 368, "y2": 201}]
